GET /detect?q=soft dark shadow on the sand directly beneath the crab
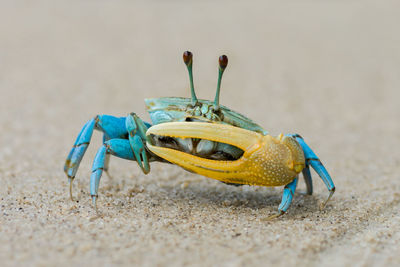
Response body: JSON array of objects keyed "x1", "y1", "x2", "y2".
[{"x1": 139, "y1": 181, "x2": 319, "y2": 219}]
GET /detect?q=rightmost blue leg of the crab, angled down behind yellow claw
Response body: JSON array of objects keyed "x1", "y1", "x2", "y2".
[{"x1": 291, "y1": 134, "x2": 335, "y2": 209}]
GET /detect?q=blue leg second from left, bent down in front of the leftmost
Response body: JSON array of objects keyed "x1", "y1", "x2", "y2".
[{"x1": 90, "y1": 139, "x2": 136, "y2": 210}]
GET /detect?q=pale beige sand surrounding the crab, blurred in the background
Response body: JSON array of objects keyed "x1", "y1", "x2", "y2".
[{"x1": 0, "y1": 1, "x2": 400, "y2": 266}]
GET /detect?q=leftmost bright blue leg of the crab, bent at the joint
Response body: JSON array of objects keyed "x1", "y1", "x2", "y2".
[{"x1": 64, "y1": 115, "x2": 127, "y2": 199}]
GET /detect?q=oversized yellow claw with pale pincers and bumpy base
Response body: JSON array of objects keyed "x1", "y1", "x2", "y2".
[{"x1": 146, "y1": 122, "x2": 305, "y2": 186}]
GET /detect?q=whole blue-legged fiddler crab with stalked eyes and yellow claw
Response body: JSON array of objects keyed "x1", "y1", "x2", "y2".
[{"x1": 64, "y1": 51, "x2": 335, "y2": 219}]
